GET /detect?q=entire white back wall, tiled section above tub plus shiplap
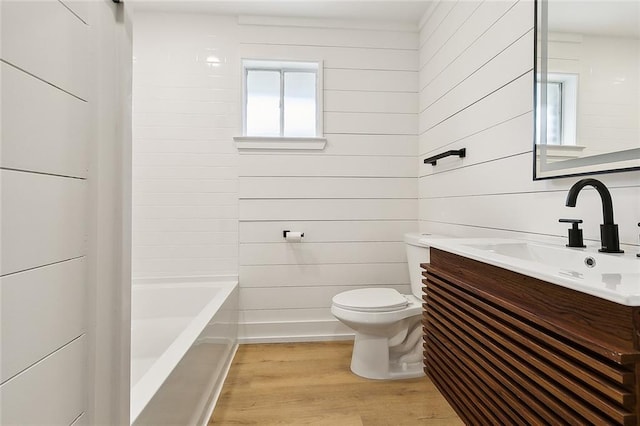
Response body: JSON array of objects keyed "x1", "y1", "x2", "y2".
[{"x1": 133, "y1": 11, "x2": 418, "y2": 341}]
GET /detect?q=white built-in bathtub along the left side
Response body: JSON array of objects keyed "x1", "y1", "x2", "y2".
[{"x1": 131, "y1": 280, "x2": 238, "y2": 425}]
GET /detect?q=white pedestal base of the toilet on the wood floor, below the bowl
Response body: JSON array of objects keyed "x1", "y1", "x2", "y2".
[{"x1": 351, "y1": 332, "x2": 425, "y2": 380}]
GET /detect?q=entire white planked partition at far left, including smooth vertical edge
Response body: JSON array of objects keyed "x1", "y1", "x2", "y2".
[{"x1": 0, "y1": 0, "x2": 131, "y2": 425}]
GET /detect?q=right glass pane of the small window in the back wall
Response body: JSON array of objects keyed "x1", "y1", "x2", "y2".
[{"x1": 283, "y1": 71, "x2": 316, "y2": 137}]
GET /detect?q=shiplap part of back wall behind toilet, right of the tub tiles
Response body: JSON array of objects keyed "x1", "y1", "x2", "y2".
[{"x1": 239, "y1": 18, "x2": 418, "y2": 341}]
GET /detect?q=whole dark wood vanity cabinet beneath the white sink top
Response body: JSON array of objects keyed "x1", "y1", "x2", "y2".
[{"x1": 422, "y1": 248, "x2": 640, "y2": 425}]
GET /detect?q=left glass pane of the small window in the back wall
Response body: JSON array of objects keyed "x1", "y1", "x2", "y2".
[{"x1": 246, "y1": 70, "x2": 280, "y2": 136}]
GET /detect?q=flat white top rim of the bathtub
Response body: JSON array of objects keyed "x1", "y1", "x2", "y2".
[{"x1": 129, "y1": 276, "x2": 238, "y2": 424}]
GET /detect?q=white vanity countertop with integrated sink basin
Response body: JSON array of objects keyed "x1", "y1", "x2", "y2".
[{"x1": 424, "y1": 237, "x2": 640, "y2": 306}]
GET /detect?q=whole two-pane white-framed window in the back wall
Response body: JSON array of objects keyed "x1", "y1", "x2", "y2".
[{"x1": 242, "y1": 60, "x2": 322, "y2": 138}]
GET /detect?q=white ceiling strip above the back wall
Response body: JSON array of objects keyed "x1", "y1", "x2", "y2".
[{"x1": 128, "y1": 0, "x2": 431, "y2": 24}]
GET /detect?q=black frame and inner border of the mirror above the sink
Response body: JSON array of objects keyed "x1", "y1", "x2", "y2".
[{"x1": 532, "y1": 0, "x2": 640, "y2": 181}]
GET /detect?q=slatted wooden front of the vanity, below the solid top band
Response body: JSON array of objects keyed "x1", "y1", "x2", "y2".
[{"x1": 423, "y1": 255, "x2": 637, "y2": 424}]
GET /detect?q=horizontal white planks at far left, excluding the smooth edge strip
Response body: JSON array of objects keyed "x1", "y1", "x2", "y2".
[{"x1": 0, "y1": 1, "x2": 93, "y2": 425}]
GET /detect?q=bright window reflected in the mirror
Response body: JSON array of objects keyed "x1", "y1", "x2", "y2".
[{"x1": 536, "y1": 73, "x2": 578, "y2": 145}]
